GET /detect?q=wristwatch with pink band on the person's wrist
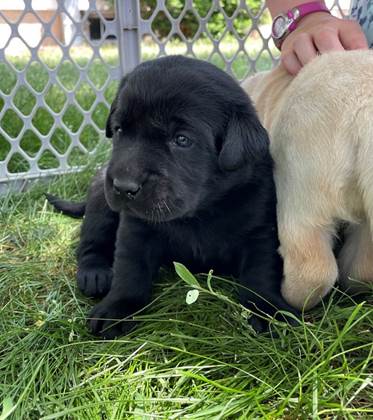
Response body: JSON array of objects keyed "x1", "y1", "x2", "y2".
[{"x1": 272, "y1": 1, "x2": 330, "y2": 50}]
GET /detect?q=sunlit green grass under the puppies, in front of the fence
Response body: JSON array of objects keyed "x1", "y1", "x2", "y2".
[{"x1": 0, "y1": 150, "x2": 373, "y2": 420}]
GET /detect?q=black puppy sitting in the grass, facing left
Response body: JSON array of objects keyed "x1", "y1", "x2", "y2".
[{"x1": 49, "y1": 56, "x2": 294, "y2": 338}]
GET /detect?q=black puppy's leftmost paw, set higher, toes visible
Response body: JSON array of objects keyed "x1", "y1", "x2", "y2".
[{"x1": 77, "y1": 266, "x2": 113, "y2": 297}]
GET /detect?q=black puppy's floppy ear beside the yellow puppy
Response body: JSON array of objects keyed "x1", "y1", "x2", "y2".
[{"x1": 219, "y1": 110, "x2": 269, "y2": 171}]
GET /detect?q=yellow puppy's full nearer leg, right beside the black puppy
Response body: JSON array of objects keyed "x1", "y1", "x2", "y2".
[{"x1": 275, "y1": 150, "x2": 340, "y2": 309}]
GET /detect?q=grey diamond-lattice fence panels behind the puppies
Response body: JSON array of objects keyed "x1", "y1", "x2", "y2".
[{"x1": 0, "y1": 0, "x2": 350, "y2": 186}]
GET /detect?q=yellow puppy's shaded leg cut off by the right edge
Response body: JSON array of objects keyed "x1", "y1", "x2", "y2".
[{"x1": 338, "y1": 221, "x2": 373, "y2": 293}]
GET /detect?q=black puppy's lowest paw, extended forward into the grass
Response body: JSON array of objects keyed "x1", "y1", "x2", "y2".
[{"x1": 89, "y1": 299, "x2": 137, "y2": 340}]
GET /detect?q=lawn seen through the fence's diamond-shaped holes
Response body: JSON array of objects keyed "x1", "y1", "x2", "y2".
[{"x1": 0, "y1": 38, "x2": 272, "y2": 174}]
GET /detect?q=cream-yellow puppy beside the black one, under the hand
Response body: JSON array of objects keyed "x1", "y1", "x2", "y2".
[{"x1": 243, "y1": 51, "x2": 373, "y2": 308}]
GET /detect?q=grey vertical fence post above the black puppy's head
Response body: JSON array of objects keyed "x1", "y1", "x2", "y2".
[{"x1": 115, "y1": 0, "x2": 140, "y2": 75}]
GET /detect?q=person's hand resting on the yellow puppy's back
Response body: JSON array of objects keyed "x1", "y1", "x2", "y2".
[{"x1": 281, "y1": 12, "x2": 368, "y2": 75}]
